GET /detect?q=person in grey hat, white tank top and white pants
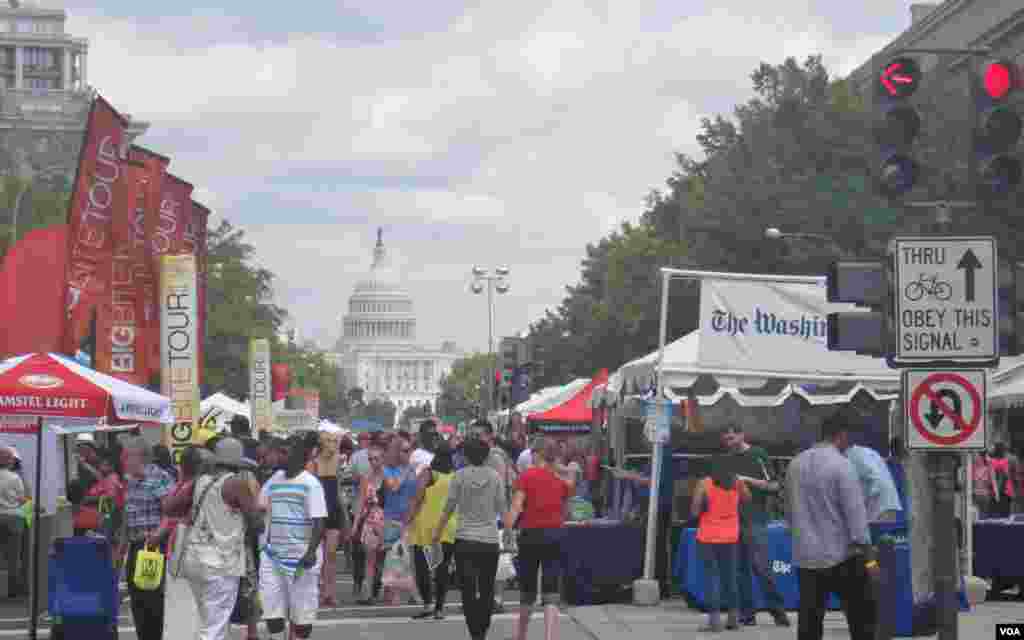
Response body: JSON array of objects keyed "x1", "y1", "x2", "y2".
[{"x1": 183, "y1": 437, "x2": 260, "y2": 640}]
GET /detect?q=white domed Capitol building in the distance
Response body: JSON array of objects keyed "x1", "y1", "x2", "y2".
[{"x1": 331, "y1": 229, "x2": 464, "y2": 417}]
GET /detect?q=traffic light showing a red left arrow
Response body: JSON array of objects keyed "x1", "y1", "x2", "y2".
[{"x1": 872, "y1": 56, "x2": 921, "y2": 198}]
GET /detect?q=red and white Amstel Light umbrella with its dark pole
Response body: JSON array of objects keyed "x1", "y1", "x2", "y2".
[{"x1": 0, "y1": 353, "x2": 173, "y2": 640}]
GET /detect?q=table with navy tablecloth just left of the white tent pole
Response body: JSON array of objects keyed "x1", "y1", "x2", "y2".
[{"x1": 562, "y1": 519, "x2": 644, "y2": 606}]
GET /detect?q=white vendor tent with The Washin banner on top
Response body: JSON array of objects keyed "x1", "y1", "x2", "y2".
[{"x1": 585, "y1": 271, "x2": 913, "y2": 604}]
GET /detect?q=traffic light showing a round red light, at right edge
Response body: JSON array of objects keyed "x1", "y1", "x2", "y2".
[{"x1": 972, "y1": 60, "x2": 1021, "y2": 198}]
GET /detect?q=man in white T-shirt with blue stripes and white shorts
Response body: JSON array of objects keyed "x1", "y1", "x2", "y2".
[{"x1": 259, "y1": 431, "x2": 327, "y2": 640}]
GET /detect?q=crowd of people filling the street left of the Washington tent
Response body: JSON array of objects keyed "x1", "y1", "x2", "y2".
[{"x1": 59, "y1": 418, "x2": 588, "y2": 640}]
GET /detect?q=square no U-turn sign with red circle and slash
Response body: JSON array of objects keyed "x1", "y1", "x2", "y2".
[{"x1": 903, "y1": 369, "x2": 988, "y2": 451}]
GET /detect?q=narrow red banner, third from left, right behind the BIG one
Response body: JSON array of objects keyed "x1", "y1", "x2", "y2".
[{"x1": 128, "y1": 145, "x2": 171, "y2": 383}]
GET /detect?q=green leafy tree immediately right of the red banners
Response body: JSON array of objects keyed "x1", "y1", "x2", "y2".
[{"x1": 203, "y1": 220, "x2": 287, "y2": 398}]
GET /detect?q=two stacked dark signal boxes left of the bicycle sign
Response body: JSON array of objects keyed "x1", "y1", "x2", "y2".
[{"x1": 825, "y1": 262, "x2": 891, "y2": 356}]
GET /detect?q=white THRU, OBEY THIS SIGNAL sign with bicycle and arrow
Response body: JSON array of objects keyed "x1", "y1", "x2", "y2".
[{"x1": 893, "y1": 237, "x2": 999, "y2": 367}]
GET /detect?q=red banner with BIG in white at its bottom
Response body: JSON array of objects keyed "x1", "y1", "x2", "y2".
[{"x1": 94, "y1": 160, "x2": 146, "y2": 385}]
